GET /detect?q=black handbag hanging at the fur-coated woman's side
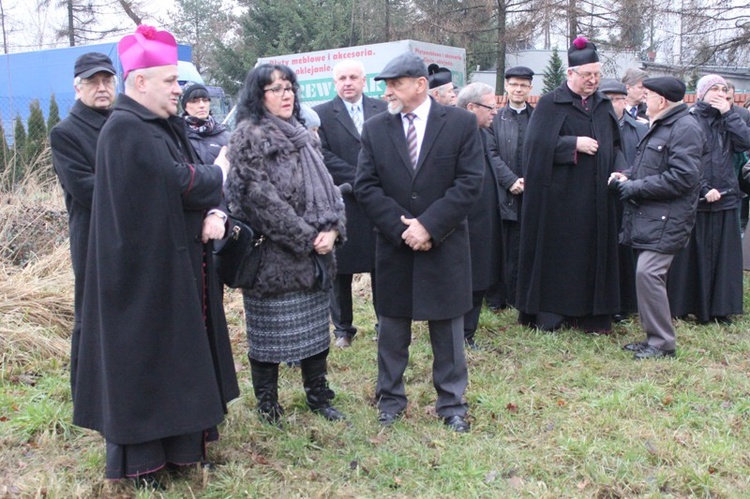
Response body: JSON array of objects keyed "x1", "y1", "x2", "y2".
[{"x1": 214, "y1": 215, "x2": 266, "y2": 288}]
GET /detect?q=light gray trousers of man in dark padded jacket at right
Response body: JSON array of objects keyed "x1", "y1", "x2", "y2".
[{"x1": 635, "y1": 250, "x2": 675, "y2": 350}]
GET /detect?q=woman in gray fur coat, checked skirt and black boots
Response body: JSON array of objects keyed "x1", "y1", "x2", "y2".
[{"x1": 225, "y1": 64, "x2": 345, "y2": 424}]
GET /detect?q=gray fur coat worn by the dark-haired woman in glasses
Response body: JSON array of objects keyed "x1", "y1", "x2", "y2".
[{"x1": 225, "y1": 119, "x2": 346, "y2": 297}]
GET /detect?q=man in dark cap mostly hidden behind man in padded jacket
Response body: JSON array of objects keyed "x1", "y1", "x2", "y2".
[{"x1": 599, "y1": 78, "x2": 648, "y2": 322}]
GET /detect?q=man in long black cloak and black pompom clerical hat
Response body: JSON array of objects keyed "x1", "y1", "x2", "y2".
[{"x1": 516, "y1": 38, "x2": 626, "y2": 333}]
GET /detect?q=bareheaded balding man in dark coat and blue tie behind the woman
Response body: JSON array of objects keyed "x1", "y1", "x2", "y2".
[{"x1": 315, "y1": 60, "x2": 387, "y2": 348}]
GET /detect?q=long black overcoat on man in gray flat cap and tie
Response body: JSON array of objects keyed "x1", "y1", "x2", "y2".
[{"x1": 354, "y1": 100, "x2": 484, "y2": 320}]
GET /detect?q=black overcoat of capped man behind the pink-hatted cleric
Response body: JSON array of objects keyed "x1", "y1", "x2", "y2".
[{"x1": 49, "y1": 100, "x2": 109, "y2": 393}]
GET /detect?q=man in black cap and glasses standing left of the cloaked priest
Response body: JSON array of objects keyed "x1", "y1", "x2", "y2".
[{"x1": 487, "y1": 66, "x2": 534, "y2": 310}]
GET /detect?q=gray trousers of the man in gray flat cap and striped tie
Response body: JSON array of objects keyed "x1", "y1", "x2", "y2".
[{"x1": 375, "y1": 315, "x2": 469, "y2": 418}]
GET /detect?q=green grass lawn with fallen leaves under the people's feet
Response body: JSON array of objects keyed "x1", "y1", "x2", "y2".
[{"x1": 0, "y1": 279, "x2": 750, "y2": 498}]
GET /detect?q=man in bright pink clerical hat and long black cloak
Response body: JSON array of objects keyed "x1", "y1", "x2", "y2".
[{"x1": 73, "y1": 26, "x2": 239, "y2": 487}]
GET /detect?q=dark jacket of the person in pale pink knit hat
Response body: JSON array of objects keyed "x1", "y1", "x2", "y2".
[{"x1": 690, "y1": 101, "x2": 750, "y2": 211}]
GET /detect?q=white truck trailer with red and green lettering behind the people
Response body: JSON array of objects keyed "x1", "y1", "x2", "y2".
[{"x1": 258, "y1": 40, "x2": 467, "y2": 105}]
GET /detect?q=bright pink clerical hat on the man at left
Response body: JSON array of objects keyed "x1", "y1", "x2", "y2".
[{"x1": 117, "y1": 24, "x2": 177, "y2": 78}]
